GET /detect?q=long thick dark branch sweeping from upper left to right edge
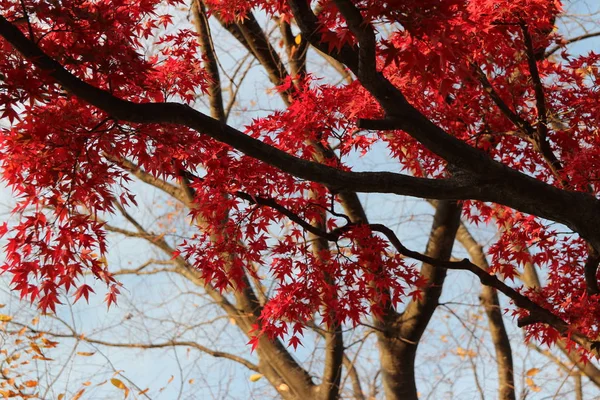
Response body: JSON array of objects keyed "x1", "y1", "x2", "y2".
[{"x1": 5, "y1": 17, "x2": 600, "y2": 248}]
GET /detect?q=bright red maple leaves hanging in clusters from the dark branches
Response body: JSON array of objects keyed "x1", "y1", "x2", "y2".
[{"x1": 0, "y1": 0, "x2": 600, "y2": 354}]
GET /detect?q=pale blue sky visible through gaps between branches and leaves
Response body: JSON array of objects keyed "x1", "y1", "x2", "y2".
[{"x1": 0, "y1": 1, "x2": 600, "y2": 400}]
